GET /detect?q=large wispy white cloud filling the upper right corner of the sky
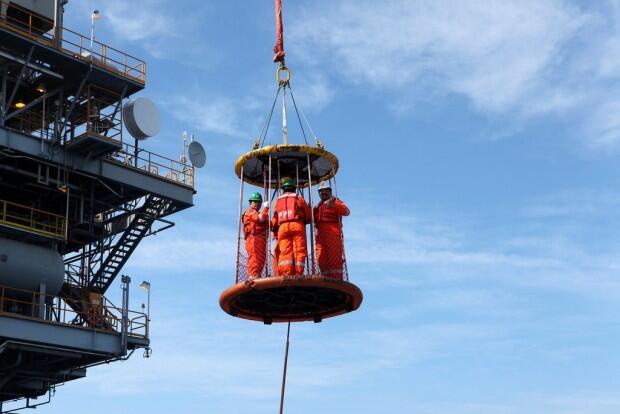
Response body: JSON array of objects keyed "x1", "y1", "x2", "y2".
[{"x1": 289, "y1": 0, "x2": 620, "y2": 150}]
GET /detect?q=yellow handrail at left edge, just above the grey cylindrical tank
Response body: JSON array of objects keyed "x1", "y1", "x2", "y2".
[{"x1": 0, "y1": 200, "x2": 66, "y2": 240}]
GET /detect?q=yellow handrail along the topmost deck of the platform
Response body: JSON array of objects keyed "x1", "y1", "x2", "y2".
[{"x1": 0, "y1": 3, "x2": 146, "y2": 84}]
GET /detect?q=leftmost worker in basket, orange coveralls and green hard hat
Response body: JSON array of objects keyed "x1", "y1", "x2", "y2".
[{"x1": 242, "y1": 192, "x2": 269, "y2": 279}]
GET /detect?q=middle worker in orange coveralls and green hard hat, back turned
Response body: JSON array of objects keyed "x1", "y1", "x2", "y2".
[{"x1": 271, "y1": 178, "x2": 312, "y2": 276}]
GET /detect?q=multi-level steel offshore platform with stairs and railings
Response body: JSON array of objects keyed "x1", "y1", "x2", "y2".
[{"x1": 0, "y1": 0, "x2": 196, "y2": 413}]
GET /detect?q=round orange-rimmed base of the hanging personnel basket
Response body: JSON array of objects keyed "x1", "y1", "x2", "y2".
[{"x1": 220, "y1": 275, "x2": 363, "y2": 324}]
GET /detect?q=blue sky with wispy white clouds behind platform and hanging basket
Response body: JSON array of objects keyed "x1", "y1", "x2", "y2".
[{"x1": 41, "y1": 0, "x2": 620, "y2": 414}]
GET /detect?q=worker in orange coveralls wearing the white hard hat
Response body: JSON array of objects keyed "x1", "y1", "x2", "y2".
[{"x1": 314, "y1": 181, "x2": 350, "y2": 279}]
